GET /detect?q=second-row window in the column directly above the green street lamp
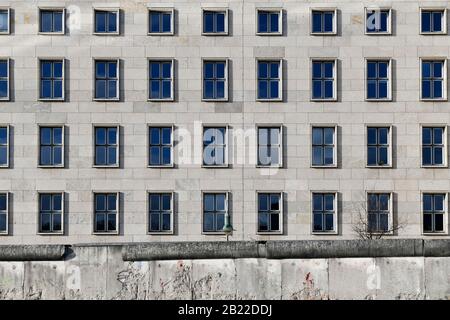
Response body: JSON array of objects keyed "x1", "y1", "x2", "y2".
[{"x1": 203, "y1": 60, "x2": 228, "y2": 101}]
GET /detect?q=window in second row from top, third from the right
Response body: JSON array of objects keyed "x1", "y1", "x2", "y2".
[{"x1": 312, "y1": 60, "x2": 336, "y2": 100}]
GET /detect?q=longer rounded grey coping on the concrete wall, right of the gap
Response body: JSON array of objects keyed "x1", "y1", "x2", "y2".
[{"x1": 122, "y1": 239, "x2": 450, "y2": 261}]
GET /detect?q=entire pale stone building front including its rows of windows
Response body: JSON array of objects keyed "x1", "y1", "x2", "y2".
[{"x1": 0, "y1": 0, "x2": 450, "y2": 244}]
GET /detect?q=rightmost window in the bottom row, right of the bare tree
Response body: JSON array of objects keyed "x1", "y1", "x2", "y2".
[{"x1": 422, "y1": 193, "x2": 447, "y2": 233}]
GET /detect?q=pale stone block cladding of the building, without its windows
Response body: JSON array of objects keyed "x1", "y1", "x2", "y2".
[{"x1": 0, "y1": 0, "x2": 450, "y2": 244}]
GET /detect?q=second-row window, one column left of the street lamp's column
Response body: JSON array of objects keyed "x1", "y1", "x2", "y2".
[{"x1": 148, "y1": 60, "x2": 173, "y2": 101}]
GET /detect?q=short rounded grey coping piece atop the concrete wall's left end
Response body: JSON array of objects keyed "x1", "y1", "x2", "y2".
[{"x1": 0, "y1": 245, "x2": 66, "y2": 261}]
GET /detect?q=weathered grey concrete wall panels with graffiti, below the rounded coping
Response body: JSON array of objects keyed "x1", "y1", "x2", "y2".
[{"x1": 0, "y1": 246, "x2": 450, "y2": 300}]
